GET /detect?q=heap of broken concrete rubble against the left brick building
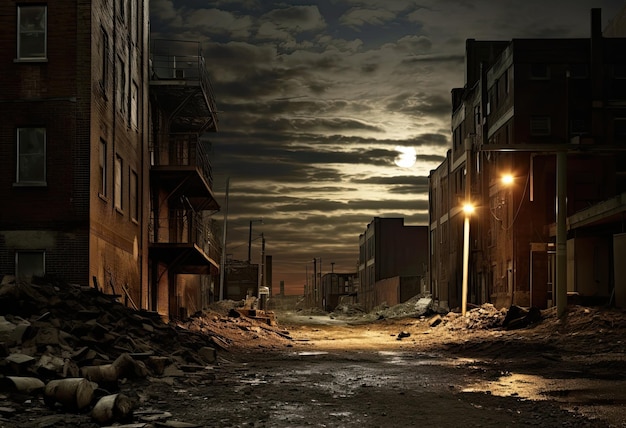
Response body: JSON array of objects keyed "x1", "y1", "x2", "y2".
[{"x1": 0, "y1": 276, "x2": 289, "y2": 427}]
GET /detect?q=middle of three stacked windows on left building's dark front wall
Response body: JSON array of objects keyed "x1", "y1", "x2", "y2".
[{"x1": 16, "y1": 128, "x2": 46, "y2": 186}]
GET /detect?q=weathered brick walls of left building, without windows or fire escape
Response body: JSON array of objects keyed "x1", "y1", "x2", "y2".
[{"x1": 0, "y1": 0, "x2": 148, "y2": 289}]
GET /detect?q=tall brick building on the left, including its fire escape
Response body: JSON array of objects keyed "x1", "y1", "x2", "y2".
[{"x1": 0, "y1": 0, "x2": 218, "y2": 315}]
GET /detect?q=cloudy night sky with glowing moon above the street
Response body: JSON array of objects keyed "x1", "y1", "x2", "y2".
[{"x1": 150, "y1": 0, "x2": 626, "y2": 294}]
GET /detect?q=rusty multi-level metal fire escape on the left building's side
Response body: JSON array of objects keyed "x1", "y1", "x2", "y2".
[{"x1": 148, "y1": 40, "x2": 221, "y2": 316}]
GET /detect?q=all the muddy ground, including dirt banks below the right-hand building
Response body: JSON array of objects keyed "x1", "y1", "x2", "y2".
[{"x1": 0, "y1": 306, "x2": 626, "y2": 427}]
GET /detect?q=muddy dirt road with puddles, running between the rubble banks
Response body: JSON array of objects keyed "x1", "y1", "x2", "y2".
[{"x1": 143, "y1": 314, "x2": 626, "y2": 427}]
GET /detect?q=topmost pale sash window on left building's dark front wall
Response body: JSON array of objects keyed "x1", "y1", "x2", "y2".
[{"x1": 17, "y1": 5, "x2": 47, "y2": 61}]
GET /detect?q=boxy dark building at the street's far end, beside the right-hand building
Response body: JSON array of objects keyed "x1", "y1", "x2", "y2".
[{"x1": 359, "y1": 217, "x2": 428, "y2": 310}]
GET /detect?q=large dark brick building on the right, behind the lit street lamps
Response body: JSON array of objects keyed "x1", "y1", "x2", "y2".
[{"x1": 430, "y1": 9, "x2": 626, "y2": 308}]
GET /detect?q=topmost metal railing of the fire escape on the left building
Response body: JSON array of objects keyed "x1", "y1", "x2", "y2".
[{"x1": 150, "y1": 39, "x2": 217, "y2": 114}]
